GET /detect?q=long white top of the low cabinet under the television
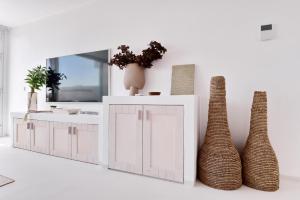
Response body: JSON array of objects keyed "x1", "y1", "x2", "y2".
[{"x1": 10, "y1": 112, "x2": 102, "y2": 124}]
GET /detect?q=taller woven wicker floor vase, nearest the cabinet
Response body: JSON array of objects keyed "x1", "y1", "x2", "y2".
[{"x1": 198, "y1": 76, "x2": 242, "y2": 190}]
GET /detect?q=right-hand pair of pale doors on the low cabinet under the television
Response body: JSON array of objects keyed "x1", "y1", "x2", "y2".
[{"x1": 50, "y1": 122, "x2": 98, "y2": 163}]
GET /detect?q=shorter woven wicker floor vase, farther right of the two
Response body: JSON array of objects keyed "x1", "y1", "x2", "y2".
[{"x1": 242, "y1": 91, "x2": 279, "y2": 191}]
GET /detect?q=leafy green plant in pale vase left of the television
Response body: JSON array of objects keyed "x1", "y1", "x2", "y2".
[{"x1": 25, "y1": 65, "x2": 47, "y2": 111}]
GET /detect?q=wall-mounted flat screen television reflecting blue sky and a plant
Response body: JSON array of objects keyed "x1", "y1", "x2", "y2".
[{"x1": 46, "y1": 50, "x2": 109, "y2": 102}]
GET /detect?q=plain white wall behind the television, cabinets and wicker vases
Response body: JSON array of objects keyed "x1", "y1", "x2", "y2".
[{"x1": 9, "y1": 0, "x2": 300, "y2": 177}]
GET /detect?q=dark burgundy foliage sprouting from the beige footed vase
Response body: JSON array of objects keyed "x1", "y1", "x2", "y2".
[{"x1": 109, "y1": 41, "x2": 167, "y2": 69}]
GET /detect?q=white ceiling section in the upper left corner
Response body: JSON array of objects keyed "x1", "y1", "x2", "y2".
[{"x1": 0, "y1": 0, "x2": 93, "y2": 27}]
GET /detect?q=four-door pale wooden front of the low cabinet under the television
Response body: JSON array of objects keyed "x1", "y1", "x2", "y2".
[{"x1": 13, "y1": 114, "x2": 99, "y2": 164}]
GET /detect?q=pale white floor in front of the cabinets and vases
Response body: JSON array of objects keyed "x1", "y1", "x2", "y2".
[{"x1": 0, "y1": 138, "x2": 300, "y2": 200}]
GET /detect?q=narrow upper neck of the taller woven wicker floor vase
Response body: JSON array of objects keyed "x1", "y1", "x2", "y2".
[{"x1": 207, "y1": 76, "x2": 230, "y2": 136}]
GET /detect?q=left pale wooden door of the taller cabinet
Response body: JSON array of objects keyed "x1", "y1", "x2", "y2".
[{"x1": 109, "y1": 105, "x2": 143, "y2": 174}]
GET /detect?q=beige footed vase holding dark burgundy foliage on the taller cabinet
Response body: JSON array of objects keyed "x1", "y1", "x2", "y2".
[{"x1": 109, "y1": 41, "x2": 167, "y2": 96}]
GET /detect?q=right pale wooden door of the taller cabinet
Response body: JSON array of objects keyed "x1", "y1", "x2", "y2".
[{"x1": 143, "y1": 105, "x2": 183, "y2": 183}]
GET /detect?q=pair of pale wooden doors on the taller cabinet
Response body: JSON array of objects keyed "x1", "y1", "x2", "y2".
[{"x1": 109, "y1": 105, "x2": 183, "y2": 183}]
